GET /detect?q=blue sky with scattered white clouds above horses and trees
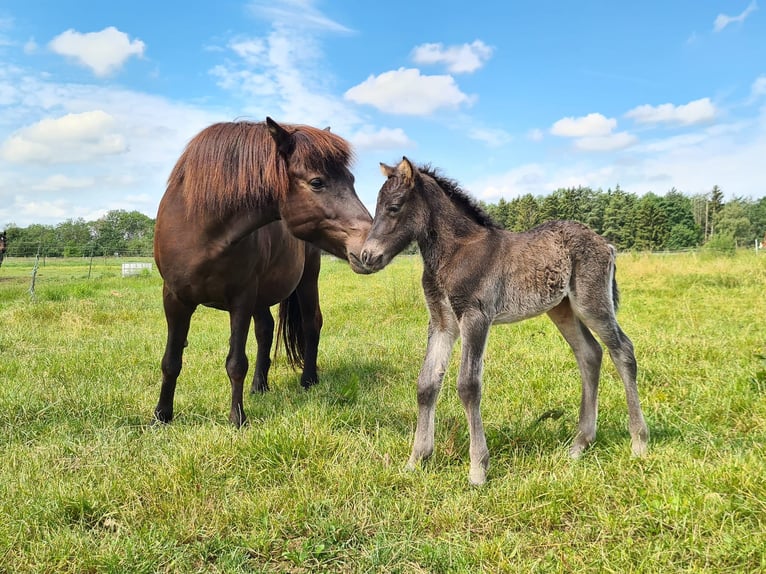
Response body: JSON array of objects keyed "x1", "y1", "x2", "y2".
[{"x1": 0, "y1": 0, "x2": 766, "y2": 227}]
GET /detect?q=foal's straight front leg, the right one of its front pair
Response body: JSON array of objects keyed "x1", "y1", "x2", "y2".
[{"x1": 457, "y1": 312, "x2": 491, "y2": 485}]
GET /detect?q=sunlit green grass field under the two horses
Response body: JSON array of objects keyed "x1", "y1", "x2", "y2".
[{"x1": 0, "y1": 253, "x2": 766, "y2": 573}]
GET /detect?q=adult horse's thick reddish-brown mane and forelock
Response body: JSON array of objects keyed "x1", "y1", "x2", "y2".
[{"x1": 168, "y1": 121, "x2": 353, "y2": 217}]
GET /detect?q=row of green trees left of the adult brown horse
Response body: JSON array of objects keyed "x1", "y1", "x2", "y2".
[{"x1": 5, "y1": 210, "x2": 154, "y2": 257}]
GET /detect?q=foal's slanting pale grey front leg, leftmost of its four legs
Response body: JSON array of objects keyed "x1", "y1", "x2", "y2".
[{"x1": 405, "y1": 311, "x2": 458, "y2": 470}]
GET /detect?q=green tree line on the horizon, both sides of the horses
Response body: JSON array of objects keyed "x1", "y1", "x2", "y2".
[{"x1": 0, "y1": 186, "x2": 766, "y2": 257}]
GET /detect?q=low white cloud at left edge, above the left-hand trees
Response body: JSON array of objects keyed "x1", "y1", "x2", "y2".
[{"x1": 0, "y1": 110, "x2": 127, "y2": 163}]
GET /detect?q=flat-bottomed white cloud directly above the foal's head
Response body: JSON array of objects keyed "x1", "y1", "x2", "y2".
[{"x1": 344, "y1": 68, "x2": 474, "y2": 116}]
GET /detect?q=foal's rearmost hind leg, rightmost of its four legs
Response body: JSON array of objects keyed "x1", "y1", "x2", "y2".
[{"x1": 581, "y1": 304, "x2": 649, "y2": 456}]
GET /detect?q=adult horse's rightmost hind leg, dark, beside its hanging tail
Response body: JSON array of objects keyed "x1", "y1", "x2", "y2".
[{"x1": 295, "y1": 244, "x2": 322, "y2": 389}]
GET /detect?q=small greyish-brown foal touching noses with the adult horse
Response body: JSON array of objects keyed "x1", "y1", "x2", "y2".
[{"x1": 361, "y1": 158, "x2": 649, "y2": 484}]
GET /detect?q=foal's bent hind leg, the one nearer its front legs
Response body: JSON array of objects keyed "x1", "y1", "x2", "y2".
[{"x1": 548, "y1": 299, "x2": 604, "y2": 458}]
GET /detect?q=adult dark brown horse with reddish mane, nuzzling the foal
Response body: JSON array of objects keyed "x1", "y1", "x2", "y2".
[{"x1": 154, "y1": 118, "x2": 372, "y2": 426}]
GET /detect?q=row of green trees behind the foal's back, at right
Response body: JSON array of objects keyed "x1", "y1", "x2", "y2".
[{"x1": 483, "y1": 186, "x2": 766, "y2": 251}]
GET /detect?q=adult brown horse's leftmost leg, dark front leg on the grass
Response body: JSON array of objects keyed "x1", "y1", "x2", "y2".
[{"x1": 154, "y1": 288, "x2": 195, "y2": 423}]
